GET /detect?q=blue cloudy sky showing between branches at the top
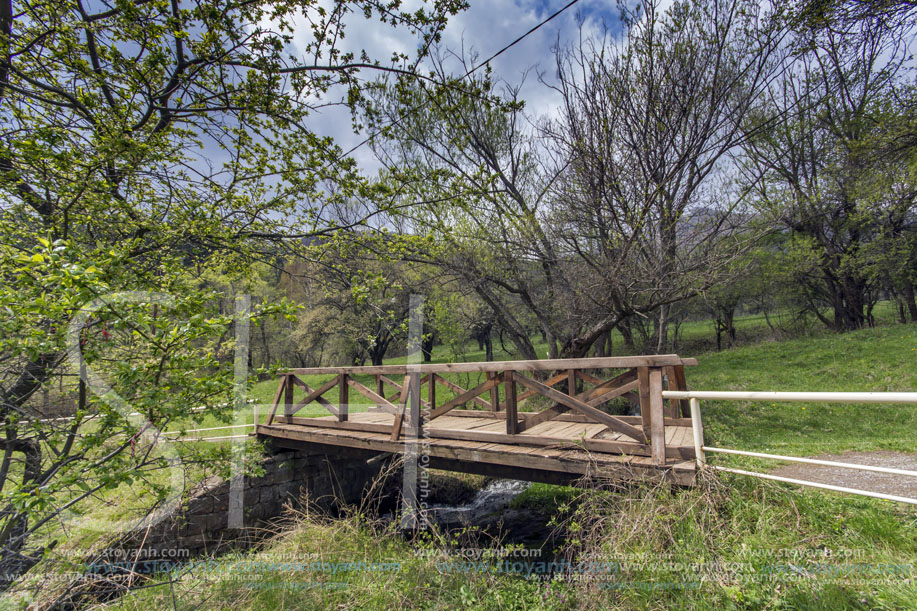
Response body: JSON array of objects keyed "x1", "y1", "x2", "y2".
[{"x1": 294, "y1": 0, "x2": 620, "y2": 172}]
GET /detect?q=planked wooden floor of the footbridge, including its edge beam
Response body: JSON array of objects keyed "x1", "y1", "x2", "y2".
[{"x1": 257, "y1": 411, "x2": 695, "y2": 485}]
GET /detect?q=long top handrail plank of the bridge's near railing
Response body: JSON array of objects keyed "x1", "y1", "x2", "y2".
[{"x1": 289, "y1": 354, "x2": 697, "y2": 375}]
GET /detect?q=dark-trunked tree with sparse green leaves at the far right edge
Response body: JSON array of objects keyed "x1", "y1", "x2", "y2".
[{"x1": 745, "y1": 10, "x2": 915, "y2": 331}]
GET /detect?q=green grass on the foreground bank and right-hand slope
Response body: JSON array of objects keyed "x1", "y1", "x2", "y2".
[{"x1": 75, "y1": 325, "x2": 917, "y2": 610}]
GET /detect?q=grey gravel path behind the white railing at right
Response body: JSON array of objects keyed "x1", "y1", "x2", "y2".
[{"x1": 771, "y1": 451, "x2": 917, "y2": 498}]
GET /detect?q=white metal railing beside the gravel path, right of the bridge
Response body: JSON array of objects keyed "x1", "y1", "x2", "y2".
[{"x1": 662, "y1": 390, "x2": 917, "y2": 505}]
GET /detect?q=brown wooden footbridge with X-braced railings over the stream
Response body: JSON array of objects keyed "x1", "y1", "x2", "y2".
[{"x1": 256, "y1": 355, "x2": 697, "y2": 485}]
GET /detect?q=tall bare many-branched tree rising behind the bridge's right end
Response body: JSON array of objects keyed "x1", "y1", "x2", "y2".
[{"x1": 549, "y1": 0, "x2": 785, "y2": 355}]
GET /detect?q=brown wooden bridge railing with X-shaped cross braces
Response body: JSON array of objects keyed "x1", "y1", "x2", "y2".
[{"x1": 268, "y1": 354, "x2": 697, "y2": 464}]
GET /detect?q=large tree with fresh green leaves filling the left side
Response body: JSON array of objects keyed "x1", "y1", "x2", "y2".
[{"x1": 0, "y1": 0, "x2": 462, "y2": 586}]
